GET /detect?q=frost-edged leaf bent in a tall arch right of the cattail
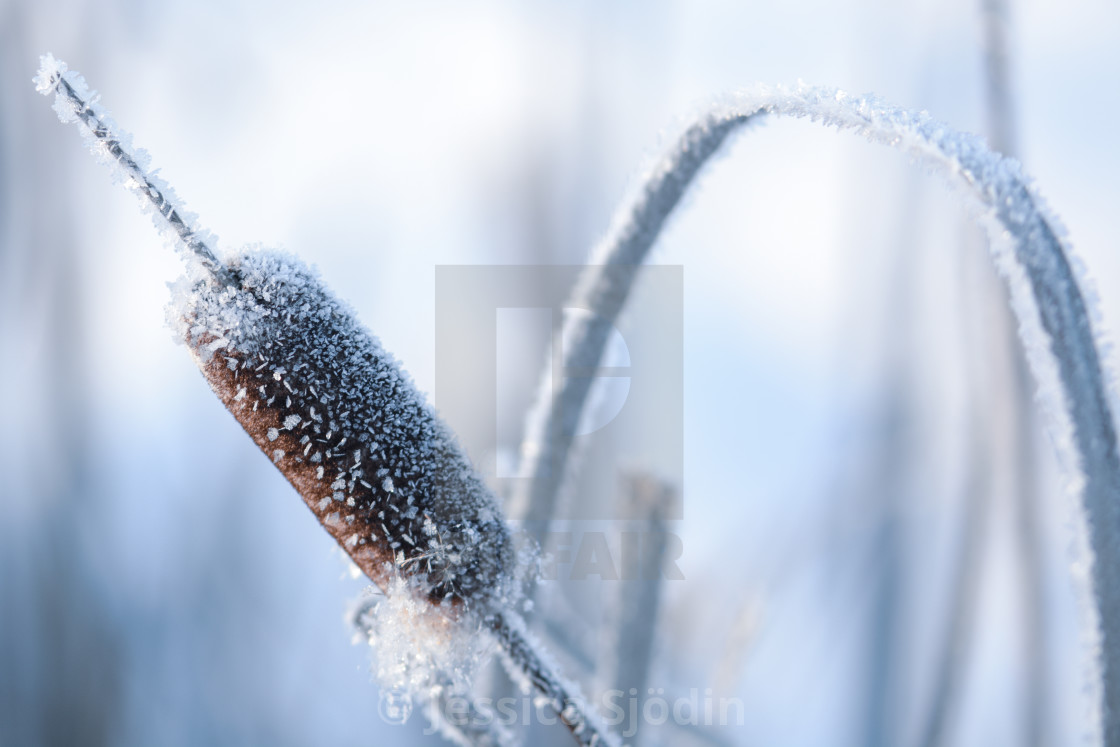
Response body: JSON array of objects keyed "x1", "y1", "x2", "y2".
[{"x1": 514, "y1": 85, "x2": 1120, "y2": 744}]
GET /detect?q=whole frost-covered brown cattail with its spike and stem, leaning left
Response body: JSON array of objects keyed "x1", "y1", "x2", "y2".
[{"x1": 35, "y1": 55, "x2": 609, "y2": 745}]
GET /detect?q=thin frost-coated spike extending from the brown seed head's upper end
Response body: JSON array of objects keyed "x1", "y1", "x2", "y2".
[{"x1": 32, "y1": 53, "x2": 231, "y2": 282}]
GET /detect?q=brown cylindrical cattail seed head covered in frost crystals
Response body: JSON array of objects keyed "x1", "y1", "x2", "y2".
[{"x1": 170, "y1": 252, "x2": 514, "y2": 613}]
